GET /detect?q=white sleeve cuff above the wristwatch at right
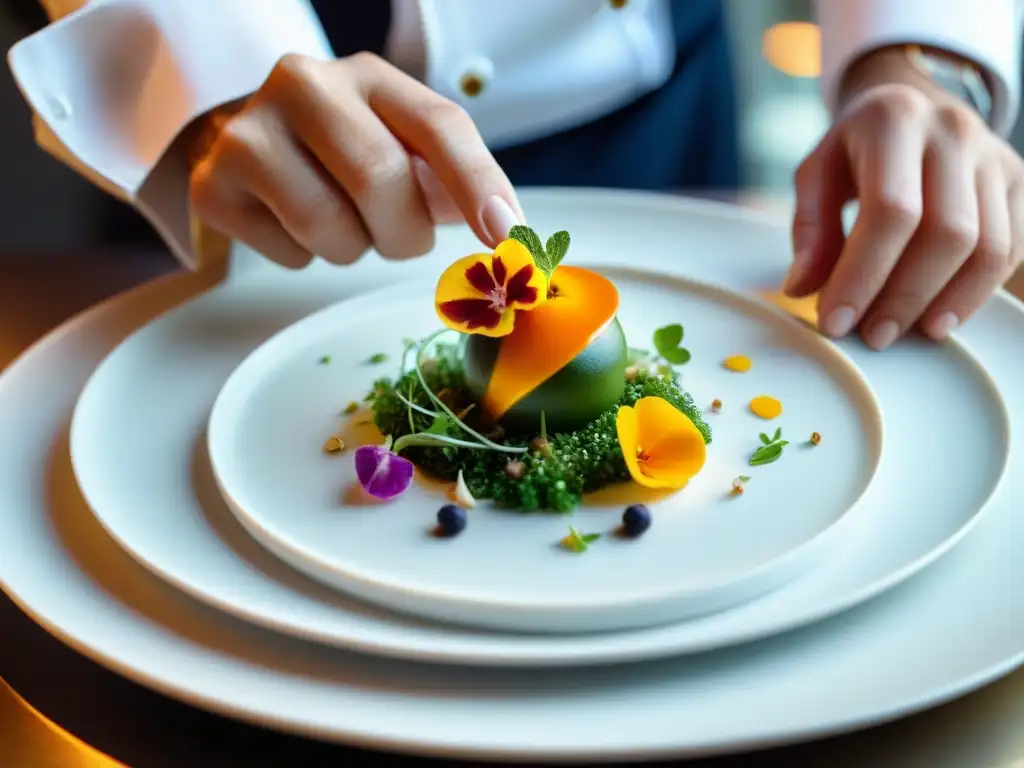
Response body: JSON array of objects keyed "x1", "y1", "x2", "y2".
[{"x1": 814, "y1": 0, "x2": 1024, "y2": 135}]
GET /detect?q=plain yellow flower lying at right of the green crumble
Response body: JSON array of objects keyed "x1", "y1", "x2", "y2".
[{"x1": 615, "y1": 397, "x2": 707, "y2": 490}]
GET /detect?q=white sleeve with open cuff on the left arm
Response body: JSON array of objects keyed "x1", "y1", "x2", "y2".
[{"x1": 8, "y1": 0, "x2": 333, "y2": 268}]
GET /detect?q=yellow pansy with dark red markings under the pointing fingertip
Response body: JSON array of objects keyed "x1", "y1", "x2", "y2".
[{"x1": 434, "y1": 240, "x2": 548, "y2": 337}]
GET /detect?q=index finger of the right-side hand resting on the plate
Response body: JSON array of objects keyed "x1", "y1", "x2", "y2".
[{"x1": 818, "y1": 112, "x2": 926, "y2": 338}]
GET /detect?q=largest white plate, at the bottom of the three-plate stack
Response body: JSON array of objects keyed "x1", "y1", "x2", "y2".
[{"x1": 0, "y1": 196, "x2": 1024, "y2": 763}]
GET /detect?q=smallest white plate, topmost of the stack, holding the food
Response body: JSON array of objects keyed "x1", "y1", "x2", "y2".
[{"x1": 203, "y1": 268, "x2": 884, "y2": 633}]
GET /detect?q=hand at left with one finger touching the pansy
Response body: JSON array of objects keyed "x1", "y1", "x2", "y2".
[{"x1": 190, "y1": 53, "x2": 523, "y2": 268}]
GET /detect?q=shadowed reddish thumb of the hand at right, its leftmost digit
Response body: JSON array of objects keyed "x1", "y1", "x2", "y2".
[{"x1": 783, "y1": 139, "x2": 854, "y2": 297}]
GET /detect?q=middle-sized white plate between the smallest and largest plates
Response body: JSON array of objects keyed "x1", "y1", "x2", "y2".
[{"x1": 74, "y1": 193, "x2": 1006, "y2": 666}]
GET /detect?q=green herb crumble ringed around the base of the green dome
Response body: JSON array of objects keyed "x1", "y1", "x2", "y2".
[{"x1": 367, "y1": 344, "x2": 711, "y2": 512}]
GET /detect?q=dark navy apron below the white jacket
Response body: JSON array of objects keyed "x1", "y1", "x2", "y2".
[{"x1": 312, "y1": 0, "x2": 739, "y2": 191}]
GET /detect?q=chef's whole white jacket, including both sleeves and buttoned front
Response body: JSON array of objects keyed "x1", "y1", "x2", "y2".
[{"x1": 8, "y1": 0, "x2": 1024, "y2": 267}]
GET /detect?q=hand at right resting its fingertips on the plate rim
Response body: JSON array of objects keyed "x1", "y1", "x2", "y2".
[{"x1": 785, "y1": 49, "x2": 1024, "y2": 349}]
